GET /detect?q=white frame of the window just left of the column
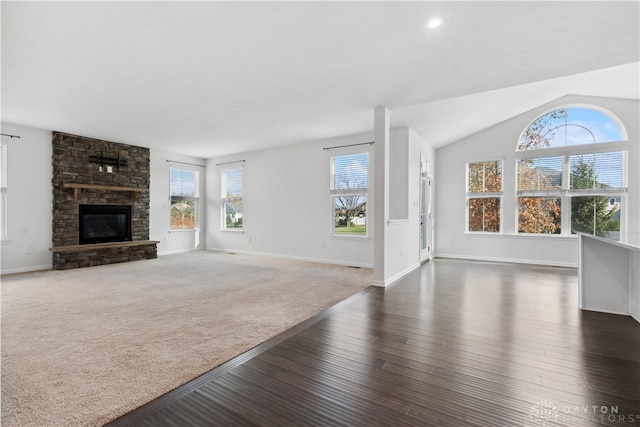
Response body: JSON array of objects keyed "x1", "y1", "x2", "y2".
[{"x1": 329, "y1": 147, "x2": 373, "y2": 239}]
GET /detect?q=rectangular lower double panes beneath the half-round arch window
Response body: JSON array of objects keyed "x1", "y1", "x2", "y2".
[{"x1": 517, "y1": 151, "x2": 626, "y2": 240}]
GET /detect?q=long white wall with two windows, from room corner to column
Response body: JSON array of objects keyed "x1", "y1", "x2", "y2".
[{"x1": 206, "y1": 134, "x2": 374, "y2": 267}]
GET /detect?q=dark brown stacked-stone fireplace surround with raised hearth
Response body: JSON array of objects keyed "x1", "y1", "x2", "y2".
[{"x1": 52, "y1": 132, "x2": 157, "y2": 269}]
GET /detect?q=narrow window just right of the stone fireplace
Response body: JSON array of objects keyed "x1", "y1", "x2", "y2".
[{"x1": 170, "y1": 167, "x2": 200, "y2": 230}]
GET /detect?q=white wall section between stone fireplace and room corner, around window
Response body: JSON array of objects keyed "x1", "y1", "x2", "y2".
[{"x1": 149, "y1": 149, "x2": 206, "y2": 256}]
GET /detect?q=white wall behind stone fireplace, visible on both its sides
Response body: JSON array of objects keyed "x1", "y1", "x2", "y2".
[{"x1": 0, "y1": 123, "x2": 206, "y2": 274}]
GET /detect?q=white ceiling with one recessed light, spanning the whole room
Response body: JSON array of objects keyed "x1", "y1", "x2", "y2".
[{"x1": 1, "y1": 1, "x2": 640, "y2": 158}]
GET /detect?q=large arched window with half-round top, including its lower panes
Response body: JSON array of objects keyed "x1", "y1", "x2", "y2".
[{"x1": 516, "y1": 107, "x2": 627, "y2": 240}]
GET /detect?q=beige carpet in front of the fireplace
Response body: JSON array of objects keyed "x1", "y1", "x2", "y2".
[{"x1": 1, "y1": 251, "x2": 372, "y2": 427}]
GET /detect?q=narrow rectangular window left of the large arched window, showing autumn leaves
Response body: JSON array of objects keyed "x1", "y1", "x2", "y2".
[{"x1": 467, "y1": 160, "x2": 502, "y2": 233}]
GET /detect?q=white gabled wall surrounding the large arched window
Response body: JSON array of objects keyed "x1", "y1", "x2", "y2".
[{"x1": 435, "y1": 96, "x2": 640, "y2": 266}]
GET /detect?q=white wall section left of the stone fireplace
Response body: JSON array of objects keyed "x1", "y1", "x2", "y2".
[{"x1": 0, "y1": 123, "x2": 53, "y2": 274}]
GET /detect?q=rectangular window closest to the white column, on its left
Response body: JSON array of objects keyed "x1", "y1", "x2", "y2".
[{"x1": 330, "y1": 152, "x2": 369, "y2": 236}]
